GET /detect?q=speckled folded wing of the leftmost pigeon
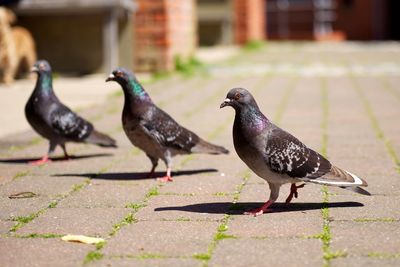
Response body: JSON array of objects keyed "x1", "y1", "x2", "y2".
[{"x1": 50, "y1": 103, "x2": 93, "y2": 142}]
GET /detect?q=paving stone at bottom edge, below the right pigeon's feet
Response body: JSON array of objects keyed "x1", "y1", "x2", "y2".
[{"x1": 209, "y1": 238, "x2": 323, "y2": 267}]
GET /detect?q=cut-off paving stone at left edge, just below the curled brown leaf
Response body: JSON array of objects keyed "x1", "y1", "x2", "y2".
[{"x1": 0, "y1": 195, "x2": 51, "y2": 220}]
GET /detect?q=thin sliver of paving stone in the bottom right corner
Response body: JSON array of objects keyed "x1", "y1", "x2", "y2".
[{"x1": 331, "y1": 256, "x2": 400, "y2": 267}]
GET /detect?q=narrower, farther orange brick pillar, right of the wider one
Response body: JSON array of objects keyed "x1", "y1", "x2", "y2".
[{"x1": 233, "y1": 0, "x2": 265, "y2": 44}]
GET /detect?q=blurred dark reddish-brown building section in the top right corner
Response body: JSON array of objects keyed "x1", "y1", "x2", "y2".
[{"x1": 265, "y1": 0, "x2": 400, "y2": 40}]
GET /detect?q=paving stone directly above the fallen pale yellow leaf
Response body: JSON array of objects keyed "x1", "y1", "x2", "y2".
[{"x1": 17, "y1": 208, "x2": 129, "y2": 237}]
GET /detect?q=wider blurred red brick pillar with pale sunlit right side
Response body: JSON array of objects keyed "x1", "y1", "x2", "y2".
[{"x1": 133, "y1": 0, "x2": 196, "y2": 71}]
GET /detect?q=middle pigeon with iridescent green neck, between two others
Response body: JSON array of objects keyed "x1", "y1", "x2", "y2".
[{"x1": 106, "y1": 68, "x2": 229, "y2": 182}]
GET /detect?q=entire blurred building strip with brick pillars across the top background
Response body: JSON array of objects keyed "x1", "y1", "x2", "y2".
[{"x1": 0, "y1": 0, "x2": 400, "y2": 74}]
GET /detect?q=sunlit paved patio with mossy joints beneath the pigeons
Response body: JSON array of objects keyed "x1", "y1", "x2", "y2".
[{"x1": 0, "y1": 43, "x2": 400, "y2": 266}]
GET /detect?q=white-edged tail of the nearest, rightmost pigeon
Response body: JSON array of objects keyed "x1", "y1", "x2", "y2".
[{"x1": 308, "y1": 165, "x2": 371, "y2": 195}]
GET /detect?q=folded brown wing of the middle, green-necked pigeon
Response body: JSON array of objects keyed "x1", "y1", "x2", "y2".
[{"x1": 140, "y1": 106, "x2": 199, "y2": 153}]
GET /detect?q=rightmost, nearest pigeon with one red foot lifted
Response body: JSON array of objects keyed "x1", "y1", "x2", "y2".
[{"x1": 220, "y1": 88, "x2": 370, "y2": 216}]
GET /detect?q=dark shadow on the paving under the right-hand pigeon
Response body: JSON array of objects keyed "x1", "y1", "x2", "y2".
[{"x1": 154, "y1": 201, "x2": 364, "y2": 215}]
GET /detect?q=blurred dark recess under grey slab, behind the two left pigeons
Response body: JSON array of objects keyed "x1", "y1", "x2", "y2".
[{"x1": 12, "y1": 0, "x2": 136, "y2": 74}]
